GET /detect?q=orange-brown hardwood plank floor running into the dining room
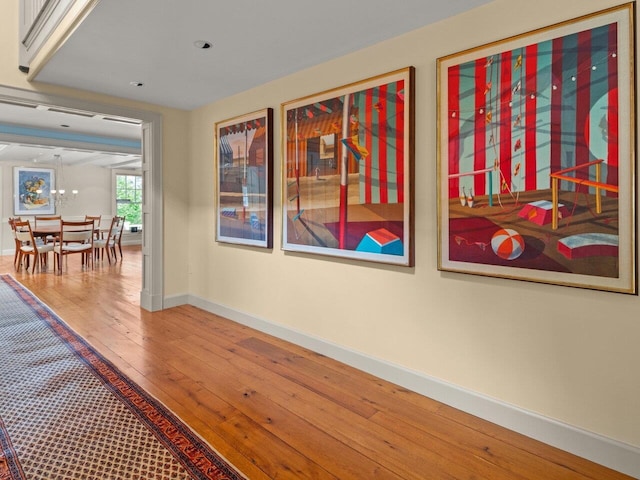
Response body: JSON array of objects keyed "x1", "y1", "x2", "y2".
[{"x1": 0, "y1": 247, "x2": 630, "y2": 480}]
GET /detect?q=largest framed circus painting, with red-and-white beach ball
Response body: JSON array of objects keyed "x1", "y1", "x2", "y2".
[{"x1": 437, "y1": 3, "x2": 637, "y2": 294}]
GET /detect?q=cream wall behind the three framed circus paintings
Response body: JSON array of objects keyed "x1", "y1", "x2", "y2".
[{"x1": 188, "y1": 0, "x2": 640, "y2": 446}]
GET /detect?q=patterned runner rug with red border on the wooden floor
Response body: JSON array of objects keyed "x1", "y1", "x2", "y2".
[{"x1": 0, "y1": 275, "x2": 244, "y2": 480}]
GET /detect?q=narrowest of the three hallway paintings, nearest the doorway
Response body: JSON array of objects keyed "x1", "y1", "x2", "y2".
[{"x1": 215, "y1": 108, "x2": 273, "y2": 248}]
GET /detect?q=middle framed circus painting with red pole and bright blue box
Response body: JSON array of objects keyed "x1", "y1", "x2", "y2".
[{"x1": 282, "y1": 67, "x2": 414, "y2": 266}]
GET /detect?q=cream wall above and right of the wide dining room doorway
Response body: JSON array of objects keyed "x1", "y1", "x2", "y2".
[{"x1": 0, "y1": 0, "x2": 189, "y2": 295}]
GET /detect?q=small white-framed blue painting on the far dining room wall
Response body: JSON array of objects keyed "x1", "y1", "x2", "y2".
[{"x1": 13, "y1": 167, "x2": 56, "y2": 215}]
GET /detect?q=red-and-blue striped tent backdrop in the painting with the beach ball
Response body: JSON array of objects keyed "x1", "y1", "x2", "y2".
[{"x1": 447, "y1": 23, "x2": 619, "y2": 198}]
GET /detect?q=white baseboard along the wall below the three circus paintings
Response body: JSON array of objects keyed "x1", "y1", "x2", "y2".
[{"x1": 172, "y1": 294, "x2": 640, "y2": 478}]
